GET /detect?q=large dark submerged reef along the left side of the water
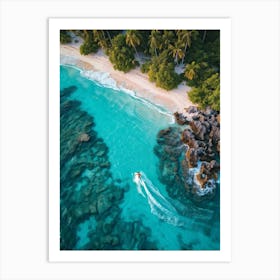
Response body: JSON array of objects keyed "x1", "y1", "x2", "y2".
[{"x1": 60, "y1": 87, "x2": 157, "y2": 250}]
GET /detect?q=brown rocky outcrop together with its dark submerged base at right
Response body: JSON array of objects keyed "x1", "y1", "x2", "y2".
[{"x1": 154, "y1": 106, "x2": 220, "y2": 201}]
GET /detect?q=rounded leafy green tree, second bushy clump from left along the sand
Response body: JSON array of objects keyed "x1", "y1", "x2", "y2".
[{"x1": 109, "y1": 34, "x2": 136, "y2": 73}]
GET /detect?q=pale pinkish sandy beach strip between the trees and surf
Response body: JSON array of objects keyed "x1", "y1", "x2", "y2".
[{"x1": 60, "y1": 43, "x2": 193, "y2": 113}]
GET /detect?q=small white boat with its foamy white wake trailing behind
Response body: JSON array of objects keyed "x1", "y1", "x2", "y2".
[{"x1": 133, "y1": 172, "x2": 185, "y2": 226}]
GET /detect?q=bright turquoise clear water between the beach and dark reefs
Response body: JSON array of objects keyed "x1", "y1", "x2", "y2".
[{"x1": 60, "y1": 66, "x2": 219, "y2": 250}]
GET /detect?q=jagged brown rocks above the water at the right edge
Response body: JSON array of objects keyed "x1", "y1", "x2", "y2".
[{"x1": 181, "y1": 107, "x2": 220, "y2": 197}]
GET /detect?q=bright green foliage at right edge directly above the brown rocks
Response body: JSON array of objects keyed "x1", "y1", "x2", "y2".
[{"x1": 189, "y1": 73, "x2": 220, "y2": 111}]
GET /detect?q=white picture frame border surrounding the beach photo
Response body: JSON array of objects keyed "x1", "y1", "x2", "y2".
[{"x1": 49, "y1": 18, "x2": 231, "y2": 262}]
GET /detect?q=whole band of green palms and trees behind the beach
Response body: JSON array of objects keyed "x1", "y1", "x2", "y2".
[{"x1": 60, "y1": 30, "x2": 220, "y2": 111}]
